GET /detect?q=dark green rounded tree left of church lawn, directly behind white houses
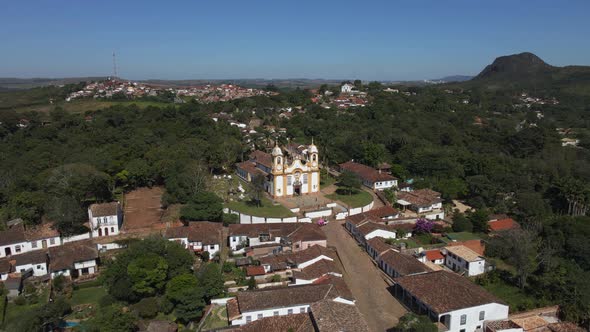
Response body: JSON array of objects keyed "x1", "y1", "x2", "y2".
[{"x1": 180, "y1": 191, "x2": 223, "y2": 221}]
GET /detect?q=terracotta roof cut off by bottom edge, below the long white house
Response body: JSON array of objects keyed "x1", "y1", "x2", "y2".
[{"x1": 235, "y1": 313, "x2": 315, "y2": 332}]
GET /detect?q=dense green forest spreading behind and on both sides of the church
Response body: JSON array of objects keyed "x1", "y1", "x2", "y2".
[{"x1": 0, "y1": 74, "x2": 590, "y2": 324}]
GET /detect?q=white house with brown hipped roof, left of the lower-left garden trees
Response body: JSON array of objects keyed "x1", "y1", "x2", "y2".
[{"x1": 49, "y1": 241, "x2": 98, "y2": 279}]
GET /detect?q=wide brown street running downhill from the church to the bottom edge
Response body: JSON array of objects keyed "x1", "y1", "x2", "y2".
[{"x1": 323, "y1": 220, "x2": 406, "y2": 332}]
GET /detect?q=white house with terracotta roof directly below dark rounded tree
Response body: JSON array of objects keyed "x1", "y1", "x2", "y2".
[{"x1": 164, "y1": 221, "x2": 223, "y2": 257}]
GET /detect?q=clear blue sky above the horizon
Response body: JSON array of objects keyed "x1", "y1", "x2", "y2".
[{"x1": 0, "y1": 0, "x2": 590, "y2": 80}]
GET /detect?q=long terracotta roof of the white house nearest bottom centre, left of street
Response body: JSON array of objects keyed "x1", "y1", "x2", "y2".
[{"x1": 236, "y1": 284, "x2": 337, "y2": 314}]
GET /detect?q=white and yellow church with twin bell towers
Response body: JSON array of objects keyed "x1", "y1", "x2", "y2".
[{"x1": 236, "y1": 141, "x2": 320, "y2": 198}]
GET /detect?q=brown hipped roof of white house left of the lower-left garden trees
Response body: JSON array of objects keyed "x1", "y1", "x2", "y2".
[{"x1": 49, "y1": 240, "x2": 98, "y2": 272}]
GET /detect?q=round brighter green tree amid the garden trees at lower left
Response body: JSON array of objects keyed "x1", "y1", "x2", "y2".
[{"x1": 127, "y1": 254, "x2": 168, "y2": 295}]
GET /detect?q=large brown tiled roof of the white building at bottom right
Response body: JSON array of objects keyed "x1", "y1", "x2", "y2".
[{"x1": 394, "y1": 271, "x2": 503, "y2": 314}]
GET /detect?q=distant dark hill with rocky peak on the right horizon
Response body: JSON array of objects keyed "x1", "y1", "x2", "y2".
[{"x1": 462, "y1": 52, "x2": 590, "y2": 96}]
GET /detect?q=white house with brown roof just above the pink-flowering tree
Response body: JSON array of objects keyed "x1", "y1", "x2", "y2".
[{"x1": 397, "y1": 189, "x2": 445, "y2": 220}]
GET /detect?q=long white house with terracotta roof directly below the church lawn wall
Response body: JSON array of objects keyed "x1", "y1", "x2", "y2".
[{"x1": 228, "y1": 223, "x2": 327, "y2": 251}]
